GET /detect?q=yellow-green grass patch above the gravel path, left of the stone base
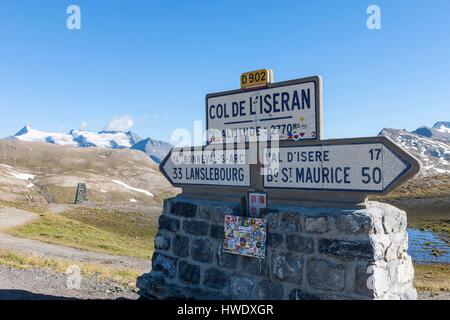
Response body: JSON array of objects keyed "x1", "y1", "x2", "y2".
[{"x1": 7, "y1": 211, "x2": 154, "y2": 259}]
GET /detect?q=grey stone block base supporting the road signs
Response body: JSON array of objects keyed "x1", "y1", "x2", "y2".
[{"x1": 137, "y1": 198, "x2": 417, "y2": 300}]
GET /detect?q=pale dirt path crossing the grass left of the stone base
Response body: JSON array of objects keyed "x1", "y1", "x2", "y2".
[{"x1": 0, "y1": 207, "x2": 151, "y2": 272}]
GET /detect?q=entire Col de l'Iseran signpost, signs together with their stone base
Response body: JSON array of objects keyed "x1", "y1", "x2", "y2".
[{"x1": 151, "y1": 71, "x2": 420, "y2": 299}]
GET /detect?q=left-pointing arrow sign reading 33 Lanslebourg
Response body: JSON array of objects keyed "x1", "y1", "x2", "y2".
[{"x1": 160, "y1": 147, "x2": 250, "y2": 187}]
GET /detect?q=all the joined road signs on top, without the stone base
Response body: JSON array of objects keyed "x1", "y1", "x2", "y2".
[{"x1": 160, "y1": 69, "x2": 420, "y2": 207}]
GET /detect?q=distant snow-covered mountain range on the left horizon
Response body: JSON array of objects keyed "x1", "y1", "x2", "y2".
[{"x1": 10, "y1": 125, "x2": 142, "y2": 149}]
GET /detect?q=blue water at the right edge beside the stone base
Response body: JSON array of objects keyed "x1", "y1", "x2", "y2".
[{"x1": 408, "y1": 229, "x2": 450, "y2": 263}]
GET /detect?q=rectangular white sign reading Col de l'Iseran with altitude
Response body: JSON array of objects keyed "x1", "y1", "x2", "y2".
[{"x1": 206, "y1": 77, "x2": 322, "y2": 143}]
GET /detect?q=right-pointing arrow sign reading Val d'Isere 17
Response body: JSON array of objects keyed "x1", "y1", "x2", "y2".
[{"x1": 263, "y1": 136, "x2": 420, "y2": 193}]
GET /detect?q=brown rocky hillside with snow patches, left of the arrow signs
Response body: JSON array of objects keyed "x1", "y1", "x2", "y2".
[{"x1": 0, "y1": 139, "x2": 175, "y2": 204}]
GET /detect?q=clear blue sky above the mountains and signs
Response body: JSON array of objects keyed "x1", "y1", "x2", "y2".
[{"x1": 0, "y1": 0, "x2": 450, "y2": 140}]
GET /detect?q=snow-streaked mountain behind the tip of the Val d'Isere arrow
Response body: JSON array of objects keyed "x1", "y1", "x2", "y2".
[{"x1": 379, "y1": 122, "x2": 450, "y2": 176}]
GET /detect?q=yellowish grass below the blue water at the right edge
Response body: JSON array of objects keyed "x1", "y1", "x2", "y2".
[{"x1": 414, "y1": 263, "x2": 450, "y2": 293}]
